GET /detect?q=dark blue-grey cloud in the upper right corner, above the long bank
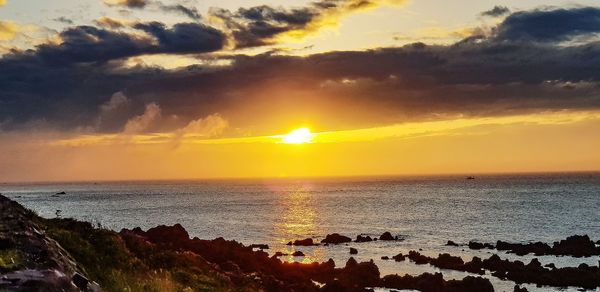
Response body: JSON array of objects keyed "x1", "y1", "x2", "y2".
[{"x1": 496, "y1": 7, "x2": 600, "y2": 42}]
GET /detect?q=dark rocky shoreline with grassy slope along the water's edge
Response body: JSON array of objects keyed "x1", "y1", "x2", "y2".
[{"x1": 0, "y1": 195, "x2": 600, "y2": 292}]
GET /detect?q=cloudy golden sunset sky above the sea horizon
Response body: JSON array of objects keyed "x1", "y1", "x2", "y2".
[{"x1": 0, "y1": 0, "x2": 600, "y2": 182}]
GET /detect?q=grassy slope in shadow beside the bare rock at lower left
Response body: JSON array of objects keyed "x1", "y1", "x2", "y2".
[{"x1": 37, "y1": 217, "x2": 240, "y2": 291}]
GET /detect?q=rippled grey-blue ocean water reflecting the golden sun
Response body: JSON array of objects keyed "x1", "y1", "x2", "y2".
[{"x1": 0, "y1": 173, "x2": 600, "y2": 291}]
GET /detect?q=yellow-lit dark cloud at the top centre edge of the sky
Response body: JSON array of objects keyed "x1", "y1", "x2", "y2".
[{"x1": 209, "y1": 0, "x2": 406, "y2": 48}]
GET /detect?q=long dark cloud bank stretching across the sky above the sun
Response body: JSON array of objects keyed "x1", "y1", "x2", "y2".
[{"x1": 0, "y1": 8, "x2": 600, "y2": 131}]
